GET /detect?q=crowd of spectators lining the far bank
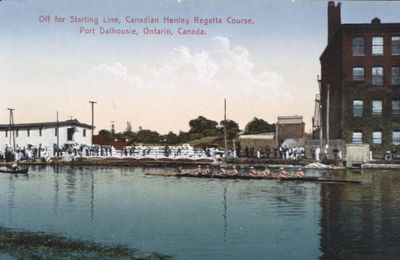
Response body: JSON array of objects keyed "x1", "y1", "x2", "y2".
[{"x1": 0, "y1": 144, "x2": 342, "y2": 161}]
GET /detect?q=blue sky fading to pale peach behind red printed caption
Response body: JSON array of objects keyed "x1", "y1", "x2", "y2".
[{"x1": 0, "y1": 0, "x2": 400, "y2": 133}]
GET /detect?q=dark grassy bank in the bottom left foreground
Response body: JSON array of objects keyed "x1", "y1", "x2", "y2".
[{"x1": 0, "y1": 227, "x2": 171, "y2": 260}]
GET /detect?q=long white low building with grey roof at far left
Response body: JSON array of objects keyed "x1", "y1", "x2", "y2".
[{"x1": 0, "y1": 119, "x2": 92, "y2": 152}]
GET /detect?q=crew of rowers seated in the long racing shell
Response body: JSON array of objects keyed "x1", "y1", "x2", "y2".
[{"x1": 178, "y1": 165, "x2": 305, "y2": 178}]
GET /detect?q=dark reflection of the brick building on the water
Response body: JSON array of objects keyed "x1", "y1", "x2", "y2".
[{"x1": 320, "y1": 171, "x2": 400, "y2": 259}]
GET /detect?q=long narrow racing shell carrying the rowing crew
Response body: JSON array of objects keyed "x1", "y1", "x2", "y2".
[{"x1": 145, "y1": 173, "x2": 362, "y2": 184}]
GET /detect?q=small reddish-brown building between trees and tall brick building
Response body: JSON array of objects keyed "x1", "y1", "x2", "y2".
[{"x1": 276, "y1": 116, "x2": 305, "y2": 145}]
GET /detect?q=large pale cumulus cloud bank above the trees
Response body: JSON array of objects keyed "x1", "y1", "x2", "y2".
[{"x1": 85, "y1": 36, "x2": 289, "y2": 132}]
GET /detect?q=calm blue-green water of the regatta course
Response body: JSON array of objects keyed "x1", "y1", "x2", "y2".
[{"x1": 0, "y1": 167, "x2": 400, "y2": 259}]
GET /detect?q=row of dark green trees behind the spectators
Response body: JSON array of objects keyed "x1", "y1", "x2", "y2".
[{"x1": 99, "y1": 116, "x2": 275, "y2": 145}]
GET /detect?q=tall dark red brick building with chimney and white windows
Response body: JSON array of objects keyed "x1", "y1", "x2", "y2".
[{"x1": 320, "y1": 1, "x2": 400, "y2": 157}]
